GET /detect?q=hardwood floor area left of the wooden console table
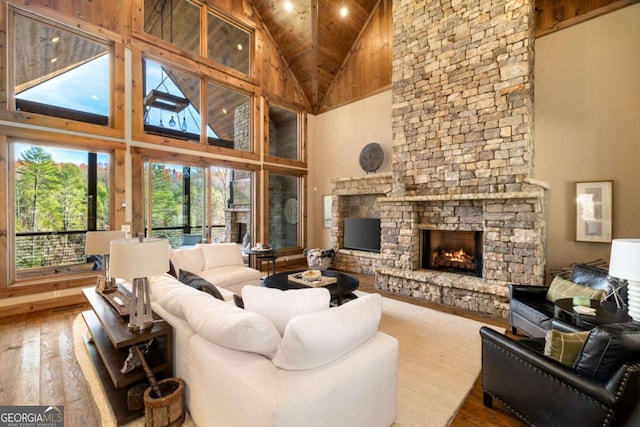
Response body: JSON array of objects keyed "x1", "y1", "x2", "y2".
[{"x1": 0, "y1": 304, "x2": 100, "y2": 427}]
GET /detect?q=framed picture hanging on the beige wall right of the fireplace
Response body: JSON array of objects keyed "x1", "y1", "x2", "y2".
[{"x1": 576, "y1": 181, "x2": 613, "y2": 243}]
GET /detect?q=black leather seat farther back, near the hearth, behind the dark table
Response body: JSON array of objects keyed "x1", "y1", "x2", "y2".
[{"x1": 509, "y1": 264, "x2": 626, "y2": 338}]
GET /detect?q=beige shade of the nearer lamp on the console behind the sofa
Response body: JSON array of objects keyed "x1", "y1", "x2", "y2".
[{"x1": 110, "y1": 239, "x2": 169, "y2": 280}]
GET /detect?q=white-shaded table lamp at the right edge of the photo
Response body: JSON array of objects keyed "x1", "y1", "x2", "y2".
[{"x1": 609, "y1": 239, "x2": 640, "y2": 321}]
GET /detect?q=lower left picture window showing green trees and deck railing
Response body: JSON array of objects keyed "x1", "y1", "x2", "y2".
[{"x1": 10, "y1": 142, "x2": 110, "y2": 279}]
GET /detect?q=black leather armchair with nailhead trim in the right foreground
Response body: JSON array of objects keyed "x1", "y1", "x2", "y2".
[{"x1": 480, "y1": 323, "x2": 640, "y2": 427}]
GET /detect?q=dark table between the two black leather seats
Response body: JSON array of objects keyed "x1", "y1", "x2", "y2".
[{"x1": 554, "y1": 298, "x2": 633, "y2": 329}]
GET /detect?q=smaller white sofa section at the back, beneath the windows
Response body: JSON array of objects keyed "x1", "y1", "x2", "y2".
[{"x1": 169, "y1": 243, "x2": 262, "y2": 294}]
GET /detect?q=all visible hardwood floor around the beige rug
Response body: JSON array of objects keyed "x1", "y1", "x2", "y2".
[{"x1": 0, "y1": 275, "x2": 525, "y2": 427}]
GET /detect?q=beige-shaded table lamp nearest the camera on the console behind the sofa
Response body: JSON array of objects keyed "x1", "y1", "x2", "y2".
[{"x1": 111, "y1": 234, "x2": 169, "y2": 331}]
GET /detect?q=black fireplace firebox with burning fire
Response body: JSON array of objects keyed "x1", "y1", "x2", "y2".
[{"x1": 421, "y1": 230, "x2": 482, "y2": 277}]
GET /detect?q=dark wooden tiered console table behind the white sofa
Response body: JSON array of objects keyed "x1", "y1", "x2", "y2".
[{"x1": 82, "y1": 287, "x2": 173, "y2": 426}]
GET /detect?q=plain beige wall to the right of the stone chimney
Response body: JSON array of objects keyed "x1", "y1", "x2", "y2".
[{"x1": 534, "y1": 4, "x2": 640, "y2": 269}]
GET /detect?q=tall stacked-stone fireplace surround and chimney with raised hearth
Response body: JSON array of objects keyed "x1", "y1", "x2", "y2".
[{"x1": 362, "y1": 0, "x2": 546, "y2": 317}]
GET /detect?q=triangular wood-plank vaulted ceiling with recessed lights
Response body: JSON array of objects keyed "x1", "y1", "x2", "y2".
[{"x1": 253, "y1": 0, "x2": 382, "y2": 110}]
